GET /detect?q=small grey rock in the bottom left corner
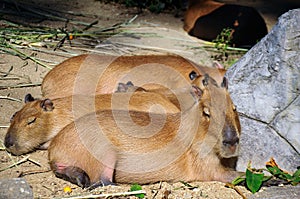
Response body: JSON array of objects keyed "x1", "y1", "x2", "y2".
[{"x1": 0, "y1": 178, "x2": 33, "y2": 199}]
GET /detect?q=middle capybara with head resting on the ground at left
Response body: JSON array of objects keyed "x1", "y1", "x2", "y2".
[{"x1": 4, "y1": 92, "x2": 180, "y2": 155}]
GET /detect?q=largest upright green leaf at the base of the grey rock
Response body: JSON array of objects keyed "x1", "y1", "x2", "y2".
[{"x1": 246, "y1": 168, "x2": 264, "y2": 193}]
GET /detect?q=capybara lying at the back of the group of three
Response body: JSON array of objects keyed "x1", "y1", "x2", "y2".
[{"x1": 41, "y1": 54, "x2": 226, "y2": 98}]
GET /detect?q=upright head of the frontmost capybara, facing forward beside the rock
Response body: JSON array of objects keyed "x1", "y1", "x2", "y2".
[{"x1": 193, "y1": 75, "x2": 241, "y2": 158}]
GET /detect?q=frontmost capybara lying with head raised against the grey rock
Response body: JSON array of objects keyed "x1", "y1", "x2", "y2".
[{"x1": 49, "y1": 76, "x2": 241, "y2": 187}]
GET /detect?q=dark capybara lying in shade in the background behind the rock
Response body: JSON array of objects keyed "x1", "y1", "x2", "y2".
[{"x1": 183, "y1": 0, "x2": 268, "y2": 48}]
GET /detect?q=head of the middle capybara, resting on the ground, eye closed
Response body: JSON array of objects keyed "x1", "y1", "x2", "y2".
[{"x1": 4, "y1": 94, "x2": 54, "y2": 155}]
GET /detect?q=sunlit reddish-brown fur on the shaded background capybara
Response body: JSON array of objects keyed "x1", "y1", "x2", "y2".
[{"x1": 183, "y1": 0, "x2": 224, "y2": 32}]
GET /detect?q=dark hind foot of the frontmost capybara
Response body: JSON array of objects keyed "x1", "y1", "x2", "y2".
[{"x1": 50, "y1": 163, "x2": 91, "y2": 188}]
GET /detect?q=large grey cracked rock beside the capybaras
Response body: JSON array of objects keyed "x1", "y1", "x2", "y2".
[{"x1": 226, "y1": 9, "x2": 300, "y2": 171}]
